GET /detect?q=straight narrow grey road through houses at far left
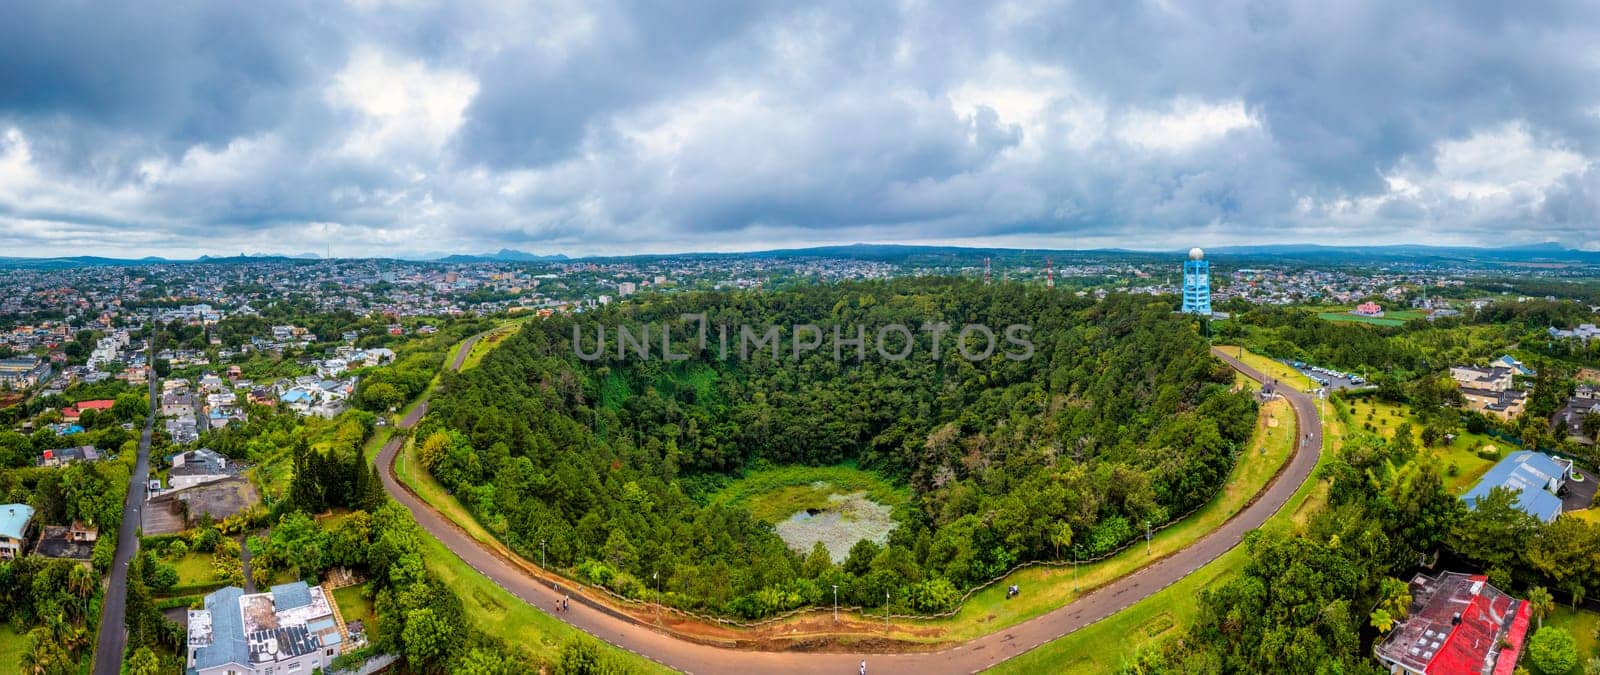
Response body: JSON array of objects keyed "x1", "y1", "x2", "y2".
[{"x1": 94, "y1": 356, "x2": 162, "y2": 675}]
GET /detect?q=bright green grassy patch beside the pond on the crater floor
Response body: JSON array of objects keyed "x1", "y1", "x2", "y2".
[{"x1": 712, "y1": 465, "x2": 909, "y2": 523}]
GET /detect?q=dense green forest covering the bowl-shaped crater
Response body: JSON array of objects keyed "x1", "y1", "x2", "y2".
[{"x1": 418, "y1": 278, "x2": 1256, "y2": 617}]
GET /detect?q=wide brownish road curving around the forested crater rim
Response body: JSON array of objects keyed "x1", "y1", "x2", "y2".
[{"x1": 378, "y1": 338, "x2": 1322, "y2": 675}]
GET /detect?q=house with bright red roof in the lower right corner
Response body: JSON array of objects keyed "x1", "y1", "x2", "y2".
[{"x1": 1373, "y1": 573, "x2": 1531, "y2": 675}]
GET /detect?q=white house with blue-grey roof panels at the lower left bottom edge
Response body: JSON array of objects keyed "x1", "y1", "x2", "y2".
[{"x1": 186, "y1": 581, "x2": 344, "y2": 675}]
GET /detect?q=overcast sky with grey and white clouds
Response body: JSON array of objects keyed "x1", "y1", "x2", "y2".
[{"x1": 0, "y1": 0, "x2": 1600, "y2": 256}]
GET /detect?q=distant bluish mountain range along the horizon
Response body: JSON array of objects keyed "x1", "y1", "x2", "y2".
[{"x1": 0, "y1": 243, "x2": 1600, "y2": 269}]
